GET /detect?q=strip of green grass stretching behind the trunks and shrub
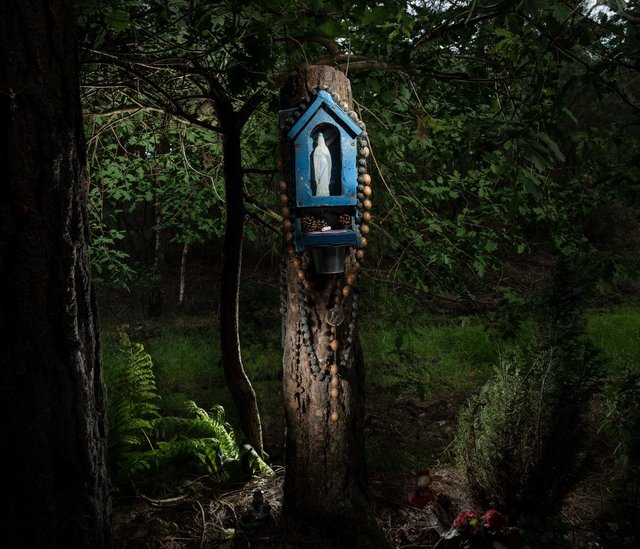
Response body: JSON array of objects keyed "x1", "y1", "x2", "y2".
[{"x1": 103, "y1": 305, "x2": 640, "y2": 470}]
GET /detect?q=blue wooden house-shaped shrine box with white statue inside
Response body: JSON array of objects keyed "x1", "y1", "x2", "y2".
[{"x1": 286, "y1": 90, "x2": 363, "y2": 253}]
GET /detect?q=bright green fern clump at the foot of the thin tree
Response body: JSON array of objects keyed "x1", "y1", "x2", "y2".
[{"x1": 105, "y1": 330, "x2": 272, "y2": 490}]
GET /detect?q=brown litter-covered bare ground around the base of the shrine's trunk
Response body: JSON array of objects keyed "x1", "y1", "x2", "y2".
[{"x1": 110, "y1": 386, "x2": 639, "y2": 549}]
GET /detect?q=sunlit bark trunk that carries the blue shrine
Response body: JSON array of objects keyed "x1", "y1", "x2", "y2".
[{"x1": 281, "y1": 66, "x2": 385, "y2": 547}]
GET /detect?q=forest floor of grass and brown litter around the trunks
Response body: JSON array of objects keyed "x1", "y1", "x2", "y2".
[{"x1": 103, "y1": 270, "x2": 640, "y2": 549}]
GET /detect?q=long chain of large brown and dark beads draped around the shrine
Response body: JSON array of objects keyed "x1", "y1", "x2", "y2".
[{"x1": 279, "y1": 86, "x2": 373, "y2": 422}]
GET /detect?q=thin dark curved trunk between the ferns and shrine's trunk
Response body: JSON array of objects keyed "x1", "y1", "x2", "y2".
[{"x1": 216, "y1": 100, "x2": 263, "y2": 456}]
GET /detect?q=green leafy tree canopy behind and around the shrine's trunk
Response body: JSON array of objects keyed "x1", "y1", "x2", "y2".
[{"x1": 80, "y1": 0, "x2": 639, "y2": 304}]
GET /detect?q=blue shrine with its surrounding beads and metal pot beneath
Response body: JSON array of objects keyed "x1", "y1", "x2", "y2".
[{"x1": 280, "y1": 89, "x2": 371, "y2": 274}]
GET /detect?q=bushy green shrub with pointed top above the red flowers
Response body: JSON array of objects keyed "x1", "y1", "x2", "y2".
[{"x1": 454, "y1": 266, "x2": 603, "y2": 518}]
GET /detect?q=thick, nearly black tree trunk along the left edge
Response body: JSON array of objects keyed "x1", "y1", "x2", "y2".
[{"x1": 0, "y1": 0, "x2": 111, "y2": 549}]
